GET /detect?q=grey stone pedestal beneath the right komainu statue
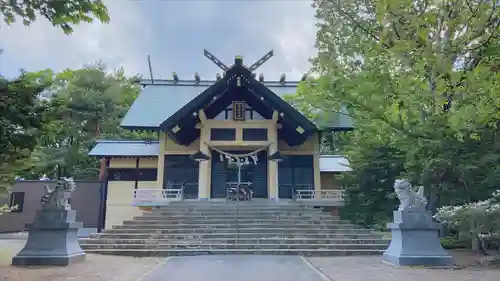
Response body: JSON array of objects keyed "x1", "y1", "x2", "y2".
[{"x1": 383, "y1": 211, "x2": 455, "y2": 266}]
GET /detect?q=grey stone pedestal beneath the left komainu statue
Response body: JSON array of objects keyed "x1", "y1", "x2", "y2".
[{"x1": 12, "y1": 208, "x2": 85, "y2": 266}]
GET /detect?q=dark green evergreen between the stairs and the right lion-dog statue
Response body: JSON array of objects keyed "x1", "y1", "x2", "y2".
[{"x1": 341, "y1": 128, "x2": 405, "y2": 229}]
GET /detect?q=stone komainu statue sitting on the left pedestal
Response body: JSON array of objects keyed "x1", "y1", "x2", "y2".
[{"x1": 40, "y1": 178, "x2": 76, "y2": 210}]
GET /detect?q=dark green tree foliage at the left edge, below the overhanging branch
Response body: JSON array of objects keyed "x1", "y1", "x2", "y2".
[{"x1": 0, "y1": 70, "x2": 52, "y2": 192}]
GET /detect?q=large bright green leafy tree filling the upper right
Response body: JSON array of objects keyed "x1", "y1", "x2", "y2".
[{"x1": 290, "y1": 0, "x2": 500, "y2": 225}]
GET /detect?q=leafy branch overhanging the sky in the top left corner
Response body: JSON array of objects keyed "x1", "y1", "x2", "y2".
[{"x1": 0, "y1": 0, "x2": 109, "y2": 34}]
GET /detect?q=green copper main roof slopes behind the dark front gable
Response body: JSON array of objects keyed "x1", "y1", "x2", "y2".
[{"x1": 121, "y1": 80, "x2": 352, "y2": 129}]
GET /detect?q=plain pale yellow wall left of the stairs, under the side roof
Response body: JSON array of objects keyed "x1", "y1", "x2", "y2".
[{"x1": 104, "y1": 181, "x2": 142, "y2": 229}]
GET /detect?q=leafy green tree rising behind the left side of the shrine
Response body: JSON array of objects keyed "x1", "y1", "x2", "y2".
[{"x1": 23, "y1": 63, "x2": 150, "y2": 180}]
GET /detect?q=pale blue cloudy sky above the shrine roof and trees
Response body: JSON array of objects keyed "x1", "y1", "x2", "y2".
[{"x1": 0, "y1": 0, "x2": 316, "y2": 80}]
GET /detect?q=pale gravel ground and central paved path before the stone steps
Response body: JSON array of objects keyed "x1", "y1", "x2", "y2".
[{"x1": 0, "y1": 239, "x2": 500, "y2": 281}]
